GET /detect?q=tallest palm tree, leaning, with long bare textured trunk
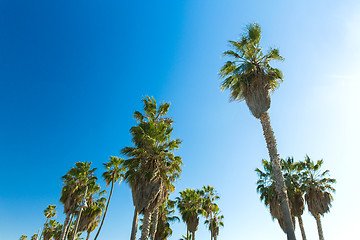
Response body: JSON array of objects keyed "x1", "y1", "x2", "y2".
[{"x1": 220, "y1": 23, "x2": 295, "y2": 240}]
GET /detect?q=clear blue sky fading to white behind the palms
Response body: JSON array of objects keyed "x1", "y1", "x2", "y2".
[{"x1": 0, "y1": 0, "x2": 360, "y2": 240}]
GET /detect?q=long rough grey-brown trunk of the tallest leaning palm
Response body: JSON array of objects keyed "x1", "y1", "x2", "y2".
[{"x1": 260, "y1": 112, "x2": 296, "y2": 240}]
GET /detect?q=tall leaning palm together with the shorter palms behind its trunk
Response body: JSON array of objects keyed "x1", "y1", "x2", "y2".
[{"x1": 219, "y1": 23, "x2": 335, "y2": 240}]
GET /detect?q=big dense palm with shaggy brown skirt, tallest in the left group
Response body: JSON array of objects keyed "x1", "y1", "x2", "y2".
[{"x1": 122, "y1": 96, "x2": 182, "y2": 240}]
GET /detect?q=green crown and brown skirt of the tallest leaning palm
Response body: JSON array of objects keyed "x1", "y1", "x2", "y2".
[{"x1": 220, "y1": 23, "x2": 283, "y2": 118}]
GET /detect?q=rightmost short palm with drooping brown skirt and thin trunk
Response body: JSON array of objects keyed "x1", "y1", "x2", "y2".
[{"x1": 300, "y1": 156, "x2": 336, "y2": 240}]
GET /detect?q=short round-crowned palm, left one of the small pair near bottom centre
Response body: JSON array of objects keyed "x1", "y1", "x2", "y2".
[{"x1": 176, "y1": 188, "x2": 206, "y2": 240}]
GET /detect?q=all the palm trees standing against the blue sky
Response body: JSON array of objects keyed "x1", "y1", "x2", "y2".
[{"x1": 19, "y1": 23, "x2": 335, "y2": 240}]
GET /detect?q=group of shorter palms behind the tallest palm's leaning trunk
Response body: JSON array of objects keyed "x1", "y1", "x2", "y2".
[{"x1": 255, "y1": 156, "x2": 335, "y2": 240}]
